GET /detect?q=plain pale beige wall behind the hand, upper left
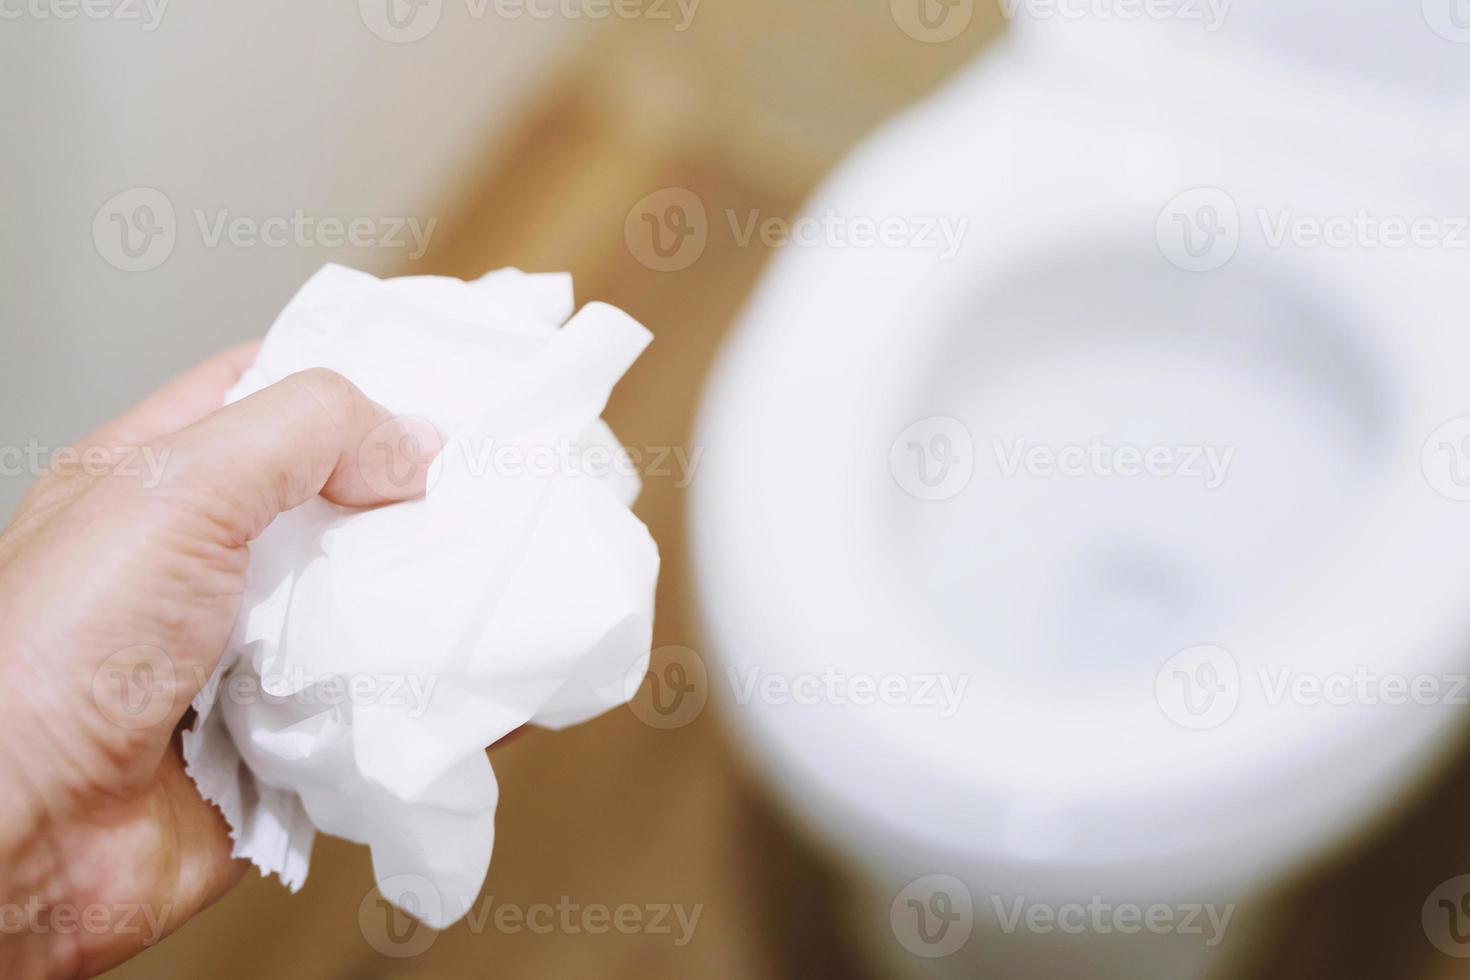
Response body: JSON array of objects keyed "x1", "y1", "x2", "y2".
[{"x1": 0, "y1": 0, "x2": 598, "y2": 516}]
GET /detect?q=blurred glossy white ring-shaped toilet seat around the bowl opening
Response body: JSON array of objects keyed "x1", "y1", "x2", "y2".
[{"x1": 694, "y1": 36, "x2": 1470, "y2": 889}]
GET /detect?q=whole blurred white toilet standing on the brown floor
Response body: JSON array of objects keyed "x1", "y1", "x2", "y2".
[{"x1": 692, "y1": 4, "x2": 1470, "y2": 979}]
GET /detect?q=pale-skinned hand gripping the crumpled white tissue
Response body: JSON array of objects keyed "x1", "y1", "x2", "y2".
[{"x1": 0, "y1": 345, "x2": 429, "y2": 977}]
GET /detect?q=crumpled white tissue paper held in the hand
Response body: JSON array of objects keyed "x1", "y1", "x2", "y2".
[{"x1": 184, "y1": 266, "x2": 659, "y2": 929}]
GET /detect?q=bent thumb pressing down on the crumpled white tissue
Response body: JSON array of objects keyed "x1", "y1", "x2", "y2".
[{"x1": 165, "y1": 369, "x2": 441, "y2": 544}]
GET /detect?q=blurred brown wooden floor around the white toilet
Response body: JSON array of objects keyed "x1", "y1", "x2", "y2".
[{"x1": 115, "y1": 9, "x2": 1470, "y2": 980}]
